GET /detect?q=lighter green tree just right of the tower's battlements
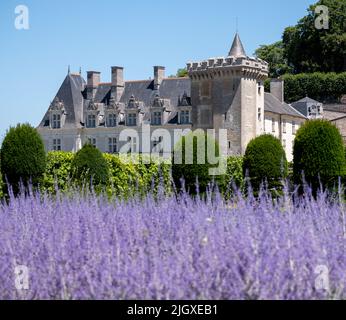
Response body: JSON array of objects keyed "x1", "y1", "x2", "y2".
[{"x1": 255, "y1": 41, "x2": 293, "y2": 78}]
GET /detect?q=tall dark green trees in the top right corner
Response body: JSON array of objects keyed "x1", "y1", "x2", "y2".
[{"x1": 283, "y1": 0, "x2": 346, "y2": 73}]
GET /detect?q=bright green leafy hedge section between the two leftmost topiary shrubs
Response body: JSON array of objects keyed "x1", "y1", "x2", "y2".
[{"x1": 42, "y1": 151, "x2": 74, "y2": 194}]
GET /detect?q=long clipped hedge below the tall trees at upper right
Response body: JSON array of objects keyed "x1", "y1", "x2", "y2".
[{"x1": 265, "y1": 72, "x2": 346, "y2": 103}]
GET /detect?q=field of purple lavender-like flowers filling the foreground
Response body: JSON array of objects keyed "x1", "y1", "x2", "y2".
[{"x1": 0, "y1": 188, "x2": 346, "y2": 299}]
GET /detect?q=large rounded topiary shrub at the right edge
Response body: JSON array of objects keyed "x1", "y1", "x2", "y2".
[{"x1": 293, "y1": 120, "x2": 345, "y2": 191}]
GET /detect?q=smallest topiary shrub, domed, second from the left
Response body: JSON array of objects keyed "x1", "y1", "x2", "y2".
[{"x1": 71, "y1": 144, "x2": 109, "y2": 186}]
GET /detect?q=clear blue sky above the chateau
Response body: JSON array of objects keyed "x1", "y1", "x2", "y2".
[{"x1": 0, "y1": 0, "x2": 315, "y2": 141}]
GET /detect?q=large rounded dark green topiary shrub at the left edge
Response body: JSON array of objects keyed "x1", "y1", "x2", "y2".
[{"x1": 1, "y1": 124, "x2": 46, "y2": 193}]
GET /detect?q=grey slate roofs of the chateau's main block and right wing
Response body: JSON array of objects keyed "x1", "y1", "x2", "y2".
[{"x1": 39, "y1": 74, "x2": 305, "y2": 128}]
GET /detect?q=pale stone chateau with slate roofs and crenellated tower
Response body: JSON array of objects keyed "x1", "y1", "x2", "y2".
[{"x1": 38, "y1": 34, "x2": 308, "y2": 161}]
